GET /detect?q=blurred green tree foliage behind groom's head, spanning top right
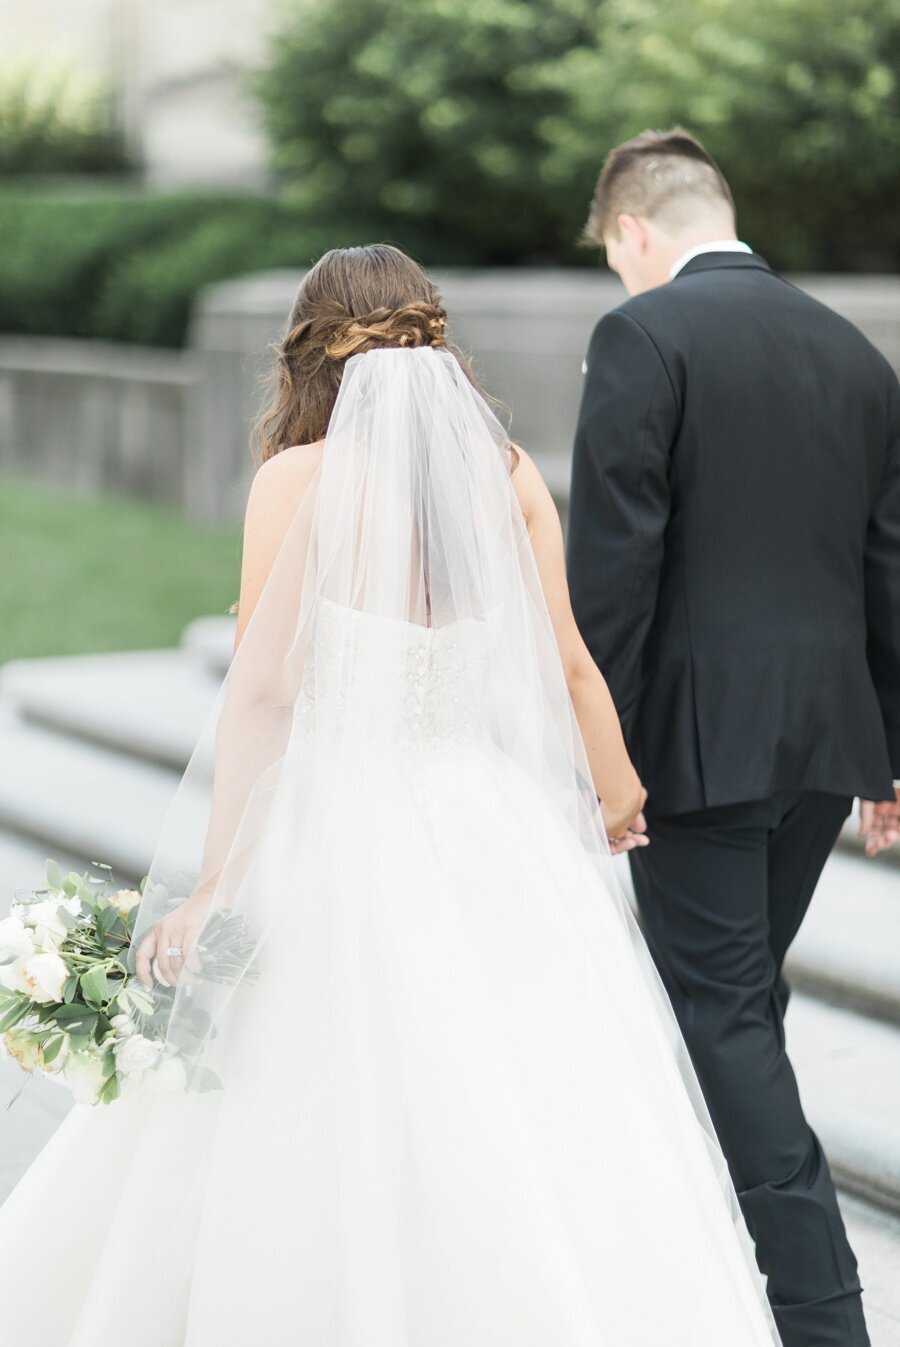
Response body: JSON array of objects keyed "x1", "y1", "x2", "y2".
[{"x1": 259, "y1": 0, "x2": 900, "y2": 269}]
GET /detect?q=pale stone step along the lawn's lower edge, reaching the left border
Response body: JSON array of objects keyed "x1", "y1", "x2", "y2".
[{"x1": 0, "y1": 649, "x2": 220, "y2": 769}]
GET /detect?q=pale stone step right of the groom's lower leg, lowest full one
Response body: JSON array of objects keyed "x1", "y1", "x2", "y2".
[{"x1": 787, "y1": 994, "x2": 900, "y2": 1212}]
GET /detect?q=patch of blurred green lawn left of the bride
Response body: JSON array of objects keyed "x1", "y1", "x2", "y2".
[{"x1": 0, "y1": 475, "x2": 240, "y2": 661}]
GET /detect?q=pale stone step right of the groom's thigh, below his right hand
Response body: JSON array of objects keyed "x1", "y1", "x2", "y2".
[{"x1": 787, "y1": 851, "x2": 900, "y2": 1025}]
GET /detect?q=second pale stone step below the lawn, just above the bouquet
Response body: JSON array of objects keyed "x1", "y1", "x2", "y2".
[{"x1": 0, "y1": 706, "x2": 202, "y2": 882}]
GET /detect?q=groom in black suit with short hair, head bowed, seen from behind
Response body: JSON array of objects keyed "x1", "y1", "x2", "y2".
[{"x1": 567, "y1": 129, "x2": 900, "y2": 1347}]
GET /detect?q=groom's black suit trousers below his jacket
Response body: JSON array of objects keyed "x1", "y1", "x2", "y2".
[{"x1": 631, "y1": 792, "x2": 869, "y2": 1347}]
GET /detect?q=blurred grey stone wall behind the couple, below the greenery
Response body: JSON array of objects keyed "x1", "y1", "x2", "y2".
[{"x1": 0, "y1": 271, "x2": 900, "y2": 520}]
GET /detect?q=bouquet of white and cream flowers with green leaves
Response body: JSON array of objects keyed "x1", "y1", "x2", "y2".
[{"x1": 0, "y1": 861, "x2": 255, "y2": 1107}]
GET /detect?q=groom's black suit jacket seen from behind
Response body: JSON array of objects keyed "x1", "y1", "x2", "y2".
[{"x1": 567, "y1": 252, "x2": 900, "y2": 814}]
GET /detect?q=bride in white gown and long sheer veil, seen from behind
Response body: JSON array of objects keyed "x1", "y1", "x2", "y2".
[{"x1": 0, "y1": 245, "x2": 779, "y2": 1347}]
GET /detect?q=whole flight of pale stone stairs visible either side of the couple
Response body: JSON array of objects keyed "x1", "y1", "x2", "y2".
[{"x1": 0, "y1": 618, "x2": 900, "y2": 1347}]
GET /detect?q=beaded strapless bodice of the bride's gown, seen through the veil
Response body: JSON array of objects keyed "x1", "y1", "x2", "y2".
[{"x1": 294, "y1": 599, "x2": 490, "y2": 752}]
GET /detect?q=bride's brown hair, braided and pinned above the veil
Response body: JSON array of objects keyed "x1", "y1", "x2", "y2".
[{"x1": 253, "y1": 244, "x2": 498, "y2": 462}]
